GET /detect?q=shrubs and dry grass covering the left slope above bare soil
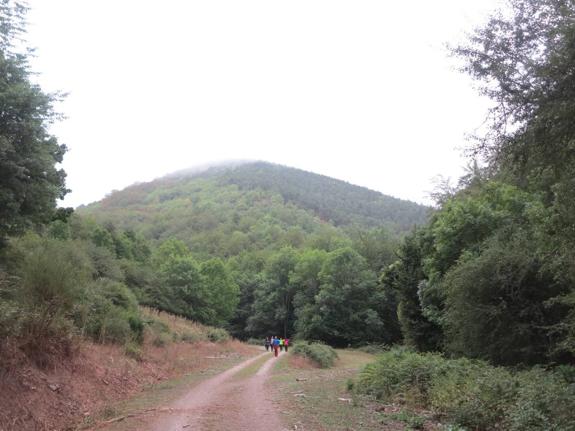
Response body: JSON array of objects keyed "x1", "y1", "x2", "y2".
[{"x1": 0, "y1": 234, "x2": 230, "y2": 368}]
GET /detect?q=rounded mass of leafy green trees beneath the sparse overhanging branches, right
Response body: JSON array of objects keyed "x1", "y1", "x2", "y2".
[{"x1": 390, "y1": 180, "x2": 573, "y2": 365}]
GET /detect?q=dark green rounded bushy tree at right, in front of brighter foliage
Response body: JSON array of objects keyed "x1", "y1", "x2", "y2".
[{"x1": 444, "y1": 233, "x2": 567, "y2": 365}]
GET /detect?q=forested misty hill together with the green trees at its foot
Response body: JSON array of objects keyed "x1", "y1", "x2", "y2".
[{"x1": 74, "y1": 162, "x2": 429, "y2": 345}]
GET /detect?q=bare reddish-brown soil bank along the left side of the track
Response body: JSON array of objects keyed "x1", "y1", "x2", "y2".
[{"x1": 0, "y1": 341, "x2": 254, "y2": 431}]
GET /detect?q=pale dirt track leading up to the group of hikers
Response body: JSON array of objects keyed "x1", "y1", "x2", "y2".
[{"x1": 149, "y1": 352, "x2": 283, "y2": 431}]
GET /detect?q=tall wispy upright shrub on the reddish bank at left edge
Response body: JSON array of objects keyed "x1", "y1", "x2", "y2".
[{"x1": 0, "y1": 234, "x2": 92, "y2": 366}]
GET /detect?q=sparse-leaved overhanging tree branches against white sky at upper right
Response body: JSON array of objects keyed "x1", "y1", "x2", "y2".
[{"x1": 453, "y1": 0, "x2": 575, "y2": 192}]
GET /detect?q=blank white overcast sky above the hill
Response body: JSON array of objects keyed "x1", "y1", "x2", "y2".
[{"x1": 28, "y1": 0, "x2": 501, "y2": 206}]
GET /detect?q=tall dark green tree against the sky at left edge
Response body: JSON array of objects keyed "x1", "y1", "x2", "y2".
[{"x1": 0, "y1": 0, "x2": 68, "y2": 246}]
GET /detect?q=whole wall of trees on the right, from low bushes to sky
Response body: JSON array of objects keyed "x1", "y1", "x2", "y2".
[{"x1": 382, "y1": 0, "x2": 575, "y2": 365}]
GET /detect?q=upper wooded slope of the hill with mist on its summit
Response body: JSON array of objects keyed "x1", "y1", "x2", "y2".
[{"x1": 78, "y1": 162, "x2": 428, "y2": 256}]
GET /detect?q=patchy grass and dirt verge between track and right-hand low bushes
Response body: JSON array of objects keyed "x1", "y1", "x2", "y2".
[{"x1": 271, "y1": 349, "x2": 442, "y2": 431}]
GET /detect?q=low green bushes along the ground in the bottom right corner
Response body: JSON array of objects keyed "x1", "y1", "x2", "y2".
[{"x1": 353, "y1": 349, "x2": 575, "y2": 431}]
